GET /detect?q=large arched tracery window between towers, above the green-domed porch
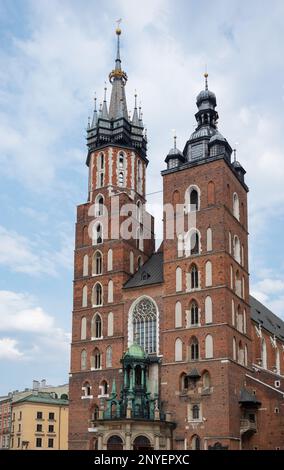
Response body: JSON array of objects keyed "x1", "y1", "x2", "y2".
[{"x1": 132, "y1": 298, "x2": 157, "y2": 354}]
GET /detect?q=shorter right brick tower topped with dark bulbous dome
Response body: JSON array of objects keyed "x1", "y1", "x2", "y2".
[{"x1": 161, "y1": 74, "x2": 251, "y2": 449}]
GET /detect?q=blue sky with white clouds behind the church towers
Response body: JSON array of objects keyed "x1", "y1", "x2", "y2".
[{"x1": 0, "y1": 0, "x2": 284, "y2": 395}]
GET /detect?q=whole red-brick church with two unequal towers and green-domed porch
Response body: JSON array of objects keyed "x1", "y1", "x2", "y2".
[{"x1": 69, "y1": 27, "x2": 284, "y2": 451}]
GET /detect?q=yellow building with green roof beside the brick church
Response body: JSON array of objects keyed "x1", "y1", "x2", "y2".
[{"x1": 10, "y1": 392, "x2": 69, "y2": 450}]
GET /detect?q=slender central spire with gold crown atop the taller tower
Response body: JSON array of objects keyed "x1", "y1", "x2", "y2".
[{"x1": 109, "y1": 26, "x2": 128, "y2": 121}]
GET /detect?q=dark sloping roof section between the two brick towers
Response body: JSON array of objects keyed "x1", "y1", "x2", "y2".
[{"x1": 124, "y1": 252, "x2": 164, "y2": 289}]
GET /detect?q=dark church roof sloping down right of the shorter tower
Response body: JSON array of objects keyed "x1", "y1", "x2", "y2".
[{"x1": 250, "y1": 296, "x2": 284, "y2": 341}]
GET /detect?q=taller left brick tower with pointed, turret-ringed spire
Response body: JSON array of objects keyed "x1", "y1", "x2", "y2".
[{"x1": 69, "y1": 28, "x2": 154, "y2": 449}]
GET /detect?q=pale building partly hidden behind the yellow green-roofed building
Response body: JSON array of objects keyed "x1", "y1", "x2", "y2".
[{"x1": 0, "y1": 379, "x2": 69, "y2": 449}]
